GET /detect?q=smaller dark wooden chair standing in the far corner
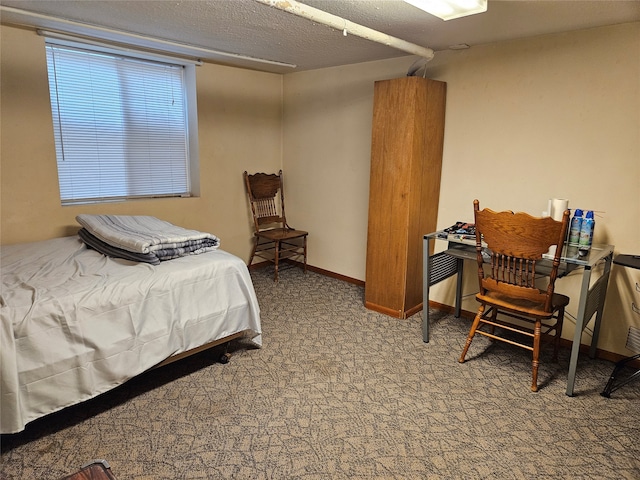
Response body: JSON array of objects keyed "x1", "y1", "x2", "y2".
[{"x1": 244, "y1": 170, "x2": 309, "y2": 281}]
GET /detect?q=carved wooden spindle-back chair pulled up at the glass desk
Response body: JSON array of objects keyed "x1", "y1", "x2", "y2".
[{"x1": 459, "y1": 200, "x2": 569, "y2": 392}]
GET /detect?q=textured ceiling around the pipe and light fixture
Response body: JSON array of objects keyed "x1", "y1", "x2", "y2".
[{"x1": 0, "y1": 0, "x2": 640, "y2": 73}]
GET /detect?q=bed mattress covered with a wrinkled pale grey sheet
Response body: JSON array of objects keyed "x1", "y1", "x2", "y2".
[{"x1": 0, "y1": 236, "x2": 262, "y2": 433}]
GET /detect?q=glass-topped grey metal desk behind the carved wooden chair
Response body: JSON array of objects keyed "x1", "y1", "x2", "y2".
[{"x1": 422, "y1": 232, "x2": 614, "y2": 396}]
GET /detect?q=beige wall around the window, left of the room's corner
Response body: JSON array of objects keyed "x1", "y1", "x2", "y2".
[{"x1": 0, "y1": 26, "x2": 282, "y2": 259}]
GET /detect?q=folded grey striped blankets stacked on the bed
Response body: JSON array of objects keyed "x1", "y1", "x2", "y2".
[{"x1": 76, "y1": 214, "x2": 220, "y2": 264}]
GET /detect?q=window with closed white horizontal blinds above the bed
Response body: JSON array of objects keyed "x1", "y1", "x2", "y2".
[{"x1": 46, "y1": 40, "x2": 197, "y2": 204}]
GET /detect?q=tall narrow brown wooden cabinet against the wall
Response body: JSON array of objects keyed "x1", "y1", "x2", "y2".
[{"x1": 365, "y1": 77, "x2": 447, "y2": 318}]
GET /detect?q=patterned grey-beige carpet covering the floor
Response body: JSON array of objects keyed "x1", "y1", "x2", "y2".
[{"x1": 0, "y1": 269, "x2": 640, "y2": 480}]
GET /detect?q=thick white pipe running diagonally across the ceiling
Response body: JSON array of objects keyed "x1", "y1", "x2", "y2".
[{"x1": 255, "y1": 0, "x2": 434, "y2": 60}]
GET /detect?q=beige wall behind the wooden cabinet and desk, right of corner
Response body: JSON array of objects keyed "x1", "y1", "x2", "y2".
[{"x1": 283, "y1": 23, "x2": 640, "y2": 354}]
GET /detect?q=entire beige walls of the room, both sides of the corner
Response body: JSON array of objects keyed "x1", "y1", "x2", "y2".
[{"x1": 0, "y1": 23, "x2": 640, "y2": 354}]
